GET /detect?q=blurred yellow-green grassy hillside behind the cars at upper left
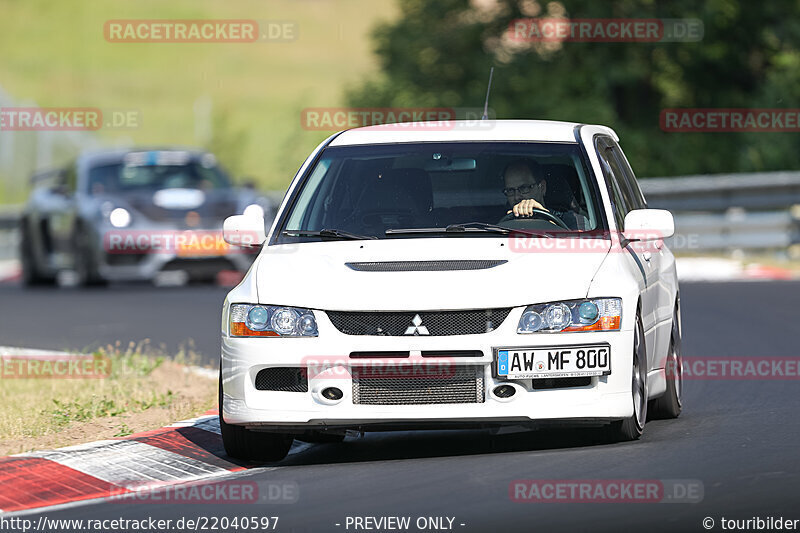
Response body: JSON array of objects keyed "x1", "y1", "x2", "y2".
[{"x1": 0, "y1": 0, "x2": 395, "y2": 203}]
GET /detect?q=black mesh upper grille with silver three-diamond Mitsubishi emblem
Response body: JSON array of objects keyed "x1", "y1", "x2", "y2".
[{"x1": 327, "y1": 308, "x2": 511, "y2": 337}]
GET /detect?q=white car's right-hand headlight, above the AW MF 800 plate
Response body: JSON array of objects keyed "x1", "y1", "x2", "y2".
[{"x1": 517, "y1": 298, "x2": 622, "y2": 333}]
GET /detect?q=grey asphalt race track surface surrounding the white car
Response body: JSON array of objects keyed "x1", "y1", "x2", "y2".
[{"x1": 0, "y1": 282, "x2": 800, "y2": 532}]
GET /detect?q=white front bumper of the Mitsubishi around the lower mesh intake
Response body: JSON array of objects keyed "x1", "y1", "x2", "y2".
[{"x1": 221, "y1": 309, "x2": 633, "y2": 431}]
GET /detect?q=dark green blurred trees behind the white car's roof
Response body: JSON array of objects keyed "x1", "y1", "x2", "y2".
[{"x1": 348, "y1": 0, "x2": 800, "y2": 176}]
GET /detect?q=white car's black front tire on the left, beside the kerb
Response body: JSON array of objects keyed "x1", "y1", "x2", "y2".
[{"x1": 219, "y1": 370, "x2": 293, "y2": 462}]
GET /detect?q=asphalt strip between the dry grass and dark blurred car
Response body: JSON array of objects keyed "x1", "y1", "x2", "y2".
[{"x1": 0, "y1": 283, "x2": 227, "y2": 365}]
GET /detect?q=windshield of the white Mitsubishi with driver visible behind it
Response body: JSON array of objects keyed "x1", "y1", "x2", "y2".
[{"x1": 278, "y1": 142, "x2": 602, "y2": 242}]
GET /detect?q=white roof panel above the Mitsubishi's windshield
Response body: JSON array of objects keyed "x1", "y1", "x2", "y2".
[{"x1": 330, "y1": 120, "x2": 617, "y2": 146}]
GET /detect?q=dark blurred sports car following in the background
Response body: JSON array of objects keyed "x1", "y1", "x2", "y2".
[{"x1": 20, "y1": 149, "x2": 275, "y2": 285}]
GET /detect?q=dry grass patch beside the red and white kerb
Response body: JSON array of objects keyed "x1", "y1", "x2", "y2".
[{"x1": 0, "y1": 341, "x2": 217, "y2": 456}]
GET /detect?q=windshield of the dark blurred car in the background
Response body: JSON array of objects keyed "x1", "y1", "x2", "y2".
[{"x1": 88, "y1": 157, "x2": 230, "y2": 195}]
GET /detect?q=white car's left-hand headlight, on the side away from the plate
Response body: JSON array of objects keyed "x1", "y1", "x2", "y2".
[{"x1": 230, "y1": 304, "x2": 319, "y2": 337}]
